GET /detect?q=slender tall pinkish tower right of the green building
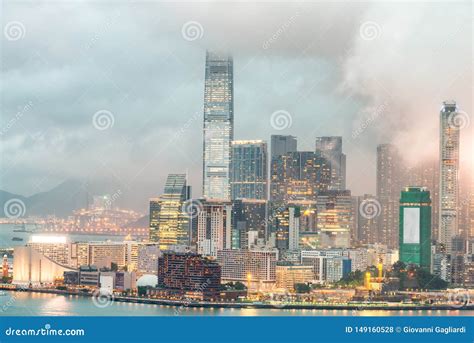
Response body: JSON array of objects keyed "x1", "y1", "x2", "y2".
[{"x1": 438, "y1": 101, "x2": 460, "y2": 254}]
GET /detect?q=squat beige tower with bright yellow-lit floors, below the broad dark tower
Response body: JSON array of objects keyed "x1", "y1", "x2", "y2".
[{"x1": 316, "y1": 190, "x2": 354, "y2": 248}]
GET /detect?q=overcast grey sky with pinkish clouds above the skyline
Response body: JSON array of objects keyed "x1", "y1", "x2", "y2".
[{"x1": 0, "y1": 1, "x2": 474, "y2": 211}]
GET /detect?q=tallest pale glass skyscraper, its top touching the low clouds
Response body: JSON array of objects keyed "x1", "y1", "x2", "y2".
[{"x1": 203, "y1": 52, "x2": 234, "y2": 200}]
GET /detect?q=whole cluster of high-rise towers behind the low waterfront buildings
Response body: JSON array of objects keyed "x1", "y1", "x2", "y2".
[{"x1": 146, "y1": 52, "x2": 474, "y2": 281}]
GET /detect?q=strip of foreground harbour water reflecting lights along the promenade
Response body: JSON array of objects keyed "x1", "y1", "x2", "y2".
[{"x1": 0, "y1": 291, "x2": 474, "y2": 316}]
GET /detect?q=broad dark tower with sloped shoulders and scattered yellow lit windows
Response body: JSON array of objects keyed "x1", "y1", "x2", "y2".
[{"x1": 270, "y1": 151, "x2": 331, "y2": 202}]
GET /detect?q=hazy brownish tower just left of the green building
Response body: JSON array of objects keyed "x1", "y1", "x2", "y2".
[{"x1": 377, "y1": 144, "x2": 403, "y2": 248}]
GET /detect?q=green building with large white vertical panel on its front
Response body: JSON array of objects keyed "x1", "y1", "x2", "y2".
[{"x1": 400, "y1": 187, "x2": 431, "y2": 271}]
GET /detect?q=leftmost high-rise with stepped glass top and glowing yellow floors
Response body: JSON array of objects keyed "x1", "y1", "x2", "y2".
[{"x1": 158, "y1": 174, "x2": 190, "y2": 250}]
